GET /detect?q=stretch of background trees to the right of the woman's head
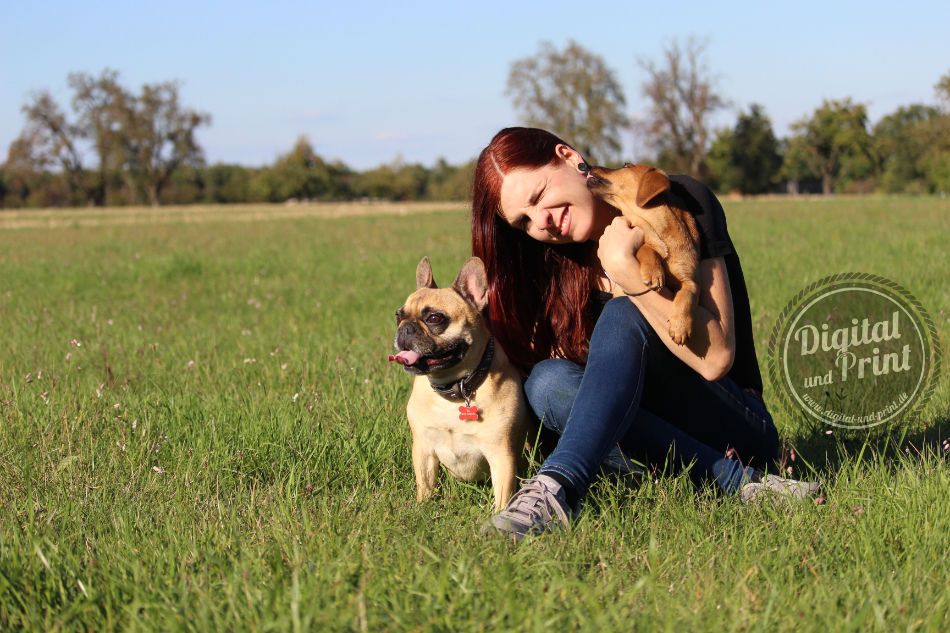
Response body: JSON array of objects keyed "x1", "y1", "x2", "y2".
[{"x1": 507, "y1": 38, "x2": 950, "y2": 194}]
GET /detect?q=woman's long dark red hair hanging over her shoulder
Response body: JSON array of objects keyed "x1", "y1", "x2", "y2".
[{"x1": 472, "y1": 127, "x2": 603, "y2": 371}]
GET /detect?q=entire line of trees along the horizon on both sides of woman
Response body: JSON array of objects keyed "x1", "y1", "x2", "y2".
[{"x1": 0, "y1": 38, "x2": 950, "y2": 208}]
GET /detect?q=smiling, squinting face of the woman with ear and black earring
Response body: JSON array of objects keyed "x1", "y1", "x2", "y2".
[{"x1": 501, "y1": 145, "x2": 612, "y2": 244}]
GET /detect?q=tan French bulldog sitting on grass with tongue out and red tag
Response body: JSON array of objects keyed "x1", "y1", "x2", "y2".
[{"x1": 389, "y1": 257, "x2": 529, "y2": 511}]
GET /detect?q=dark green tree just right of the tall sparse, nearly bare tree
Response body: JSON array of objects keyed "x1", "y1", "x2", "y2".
[{"x1": 708, "y1": 104, "x2": 782, "y2": 194}]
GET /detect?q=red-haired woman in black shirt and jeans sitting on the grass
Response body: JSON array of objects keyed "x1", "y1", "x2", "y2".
[{"x1": 480, "y1": 128, "x2": 818, "y2": 540}]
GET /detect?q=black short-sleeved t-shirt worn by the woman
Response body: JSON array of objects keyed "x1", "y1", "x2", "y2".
[{"x1": 591, "y1": 175, "x2": 762, "y2": 393}]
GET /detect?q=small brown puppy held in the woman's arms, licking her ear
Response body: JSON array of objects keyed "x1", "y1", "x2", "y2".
[{"x1": 587, "y1": 165, "x2": 699, "y2": 345}]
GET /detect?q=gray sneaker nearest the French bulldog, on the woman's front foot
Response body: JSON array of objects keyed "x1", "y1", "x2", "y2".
[{"x1": 482, "y1": 475, "x2": 577, "y2": 543}]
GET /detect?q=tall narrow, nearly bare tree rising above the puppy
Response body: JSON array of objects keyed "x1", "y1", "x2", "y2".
[{"x1": 640, "y1": 38, "x2": 726, "y2": 177}]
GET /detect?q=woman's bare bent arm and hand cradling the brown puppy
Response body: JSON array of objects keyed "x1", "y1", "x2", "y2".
[{"x1": 598, "y1": 218, "x2": 736, "y2": 381}]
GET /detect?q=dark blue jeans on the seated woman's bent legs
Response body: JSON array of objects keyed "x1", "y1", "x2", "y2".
[{"x1": 525, "y1": 297, "x2": 779, "y2": 497}]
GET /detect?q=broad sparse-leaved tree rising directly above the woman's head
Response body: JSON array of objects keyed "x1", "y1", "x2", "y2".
[{"x1": 505, "y1": 40, "x2": 629, "y2": 163}]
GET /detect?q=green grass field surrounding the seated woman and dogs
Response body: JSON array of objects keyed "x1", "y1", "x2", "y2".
[{"x1": 0, "y1": 198, "x2": 950, "y2": 632}]
